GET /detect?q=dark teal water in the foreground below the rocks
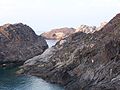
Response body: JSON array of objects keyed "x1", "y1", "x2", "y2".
[{"x1": 0, "y1": 69, "x2": 64, "y2": 90}]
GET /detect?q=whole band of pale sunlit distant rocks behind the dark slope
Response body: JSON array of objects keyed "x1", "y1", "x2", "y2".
[{"x1": 41, "y1": 22, "x2": 106, "y2": 40}]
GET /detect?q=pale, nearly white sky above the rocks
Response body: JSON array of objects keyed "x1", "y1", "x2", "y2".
[{"x1": 0, "y1": 0, "x2": 120, "y2": 35}]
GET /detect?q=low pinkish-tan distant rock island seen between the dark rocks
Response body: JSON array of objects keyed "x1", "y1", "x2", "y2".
[{"x1": 41, "y1": 27, "x2": 75, "y2": 40}]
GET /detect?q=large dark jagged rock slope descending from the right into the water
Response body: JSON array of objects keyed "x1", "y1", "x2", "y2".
[{"x1": 20, "y1": 14, "x2": 120, "y2": 90}]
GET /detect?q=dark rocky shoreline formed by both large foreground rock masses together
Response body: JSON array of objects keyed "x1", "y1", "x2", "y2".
[{"x1": 0, "y1": 14, "x2": 120, "y2": 90}]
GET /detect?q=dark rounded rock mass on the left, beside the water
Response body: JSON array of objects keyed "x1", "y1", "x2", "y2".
[{"x1": 0, "y1": 23, "x2": 48, "y2": 67}]
